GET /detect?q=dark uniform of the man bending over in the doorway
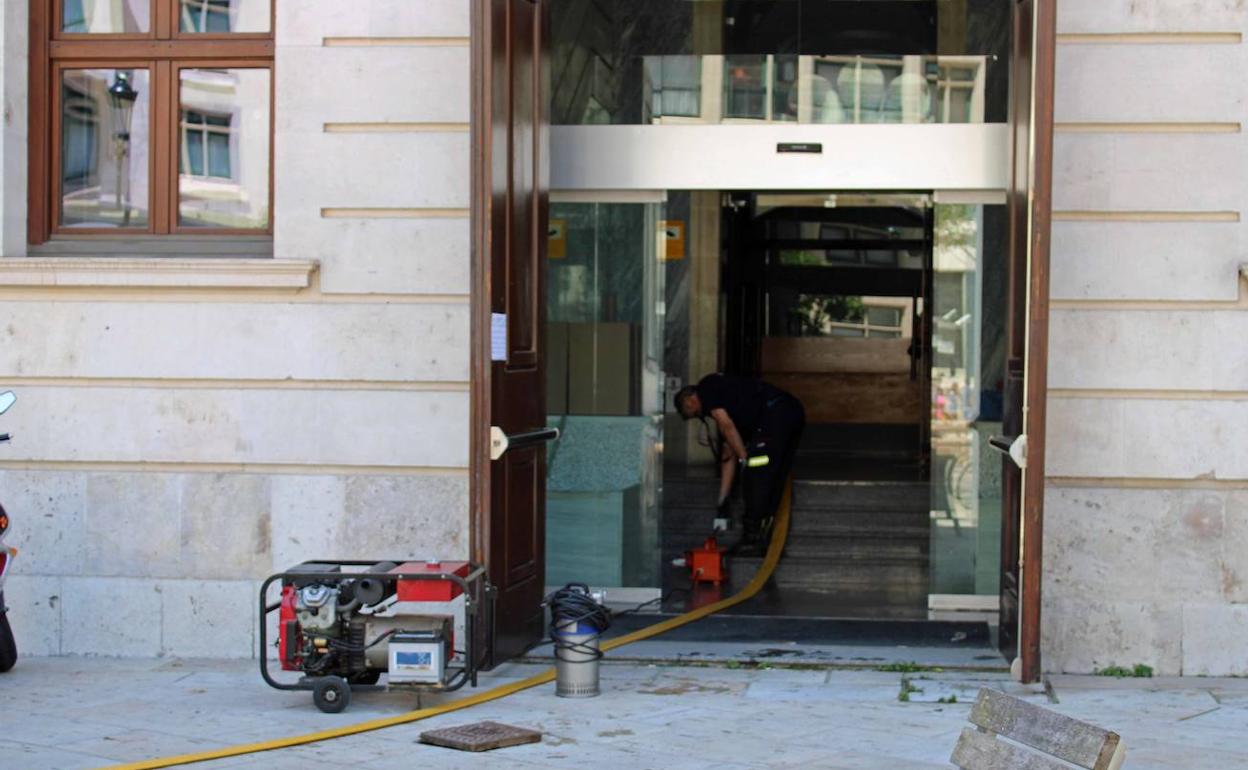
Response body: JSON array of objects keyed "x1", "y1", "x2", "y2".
[{"x1": 696, "y1": 374, "x2": 806, "y2": 538}]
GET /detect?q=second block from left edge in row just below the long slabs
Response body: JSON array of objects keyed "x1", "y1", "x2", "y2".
[{"x1": 80, "y1": 473, "x2": 182, "y2": 576}]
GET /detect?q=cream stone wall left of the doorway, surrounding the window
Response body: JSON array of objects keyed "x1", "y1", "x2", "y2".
[{"x1": 0, "y1": 0, "x2": 469, "y2": 658}]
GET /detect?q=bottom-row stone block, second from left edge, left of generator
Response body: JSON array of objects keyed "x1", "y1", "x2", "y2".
[{"x1": 61, "y1": 577, "x2": 163, "y2": 658}]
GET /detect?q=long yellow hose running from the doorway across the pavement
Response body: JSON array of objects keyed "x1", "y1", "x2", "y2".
[{"x1": 104, "y1": 482, "x2": 792, "y2": 770}]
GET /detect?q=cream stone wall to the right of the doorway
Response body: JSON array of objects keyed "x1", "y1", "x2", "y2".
[{"x1": 1041, "y1": 0, "x2": 1248, "y2": 675}]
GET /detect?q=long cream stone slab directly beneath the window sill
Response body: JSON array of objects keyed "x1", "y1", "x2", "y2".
[{"x1": 0, "y1": 302, "x2": 469, "y2": 381}]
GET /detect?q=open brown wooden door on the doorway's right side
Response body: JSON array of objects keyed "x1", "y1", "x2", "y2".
[{"x1": 993, "y1": 0, "x2": 1057, "y2": 681}]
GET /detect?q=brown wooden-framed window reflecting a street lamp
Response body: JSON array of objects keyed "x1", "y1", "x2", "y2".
[{"x1": 30, "y1": 0, "x2": 275, "y2": 245}]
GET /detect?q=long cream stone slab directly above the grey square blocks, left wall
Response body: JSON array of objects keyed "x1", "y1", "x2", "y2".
[{"x1": 6, "y1": 387, "x2": 468, "y2": 464}]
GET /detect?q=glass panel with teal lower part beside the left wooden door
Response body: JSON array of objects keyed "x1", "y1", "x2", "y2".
[{"x1": 547, "y1": 202, "x2": 666, "y2": 587}]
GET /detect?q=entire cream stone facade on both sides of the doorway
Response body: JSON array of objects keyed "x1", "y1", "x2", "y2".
[{"x1": 0, "y1": 0, "x2": 1248, "y2": 675}]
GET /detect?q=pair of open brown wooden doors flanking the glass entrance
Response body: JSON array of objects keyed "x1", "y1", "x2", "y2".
[{"x1": 470, "y1": 0, "x2": 1056, "y2": 681}]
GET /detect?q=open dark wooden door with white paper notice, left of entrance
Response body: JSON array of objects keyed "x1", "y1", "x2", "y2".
[{"x1": 470, "y1": 0, "x2": 549, "y2": 665}]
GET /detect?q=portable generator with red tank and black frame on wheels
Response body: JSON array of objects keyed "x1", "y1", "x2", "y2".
[{"x1": 260, "y1": 559, "x2": 492, "y2": 714}]
